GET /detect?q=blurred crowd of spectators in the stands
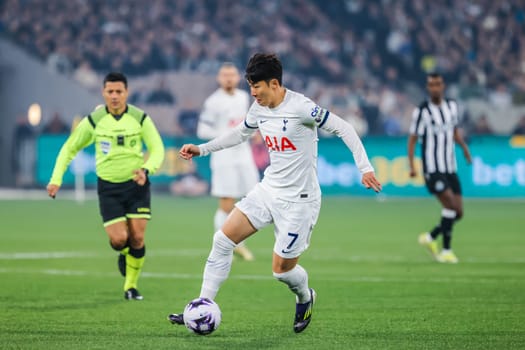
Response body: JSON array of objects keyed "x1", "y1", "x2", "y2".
[{"x1": 0, "y1": 0, "x2": 525, "y2": 136}]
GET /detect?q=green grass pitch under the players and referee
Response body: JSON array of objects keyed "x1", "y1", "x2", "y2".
[{"x1": 0, "y1": 196, "x2": 525, "y2": 350}]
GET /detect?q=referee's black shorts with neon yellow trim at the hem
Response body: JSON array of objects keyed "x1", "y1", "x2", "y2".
[{"x1": 97, "y1": 178, "x2": 151, "y2": 226}]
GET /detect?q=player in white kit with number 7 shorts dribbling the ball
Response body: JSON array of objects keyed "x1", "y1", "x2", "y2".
[{"x1": 168, "y1": 53, "x2": 381, "y2": 333}]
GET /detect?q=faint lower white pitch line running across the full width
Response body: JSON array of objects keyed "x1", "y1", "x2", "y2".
[{"x1": 0, "y1": 268, "x2": 524, "y2": 285}]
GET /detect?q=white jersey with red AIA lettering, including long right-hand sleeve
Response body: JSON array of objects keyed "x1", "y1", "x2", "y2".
[{"x1": 245, "y1": 90, "x2": 373, "y2": 202}]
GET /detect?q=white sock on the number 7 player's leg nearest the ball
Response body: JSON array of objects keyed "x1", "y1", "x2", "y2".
[{"x1": 200, "y1": 230, "x2": 235, "y2": 300}]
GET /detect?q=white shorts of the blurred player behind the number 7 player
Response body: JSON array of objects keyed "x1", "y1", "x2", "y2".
[{"x1": 211, "y1": 163, "x2": 259, "y2": 198}]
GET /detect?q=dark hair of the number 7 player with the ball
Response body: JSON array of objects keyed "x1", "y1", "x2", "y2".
[{"x1": 244, "y1": 53, "x2": 283, "y2": 85}]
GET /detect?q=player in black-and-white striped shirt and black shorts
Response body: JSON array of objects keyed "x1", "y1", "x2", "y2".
[{"x1": 408, "y1": 73, "x2": 471, "y2": 264}]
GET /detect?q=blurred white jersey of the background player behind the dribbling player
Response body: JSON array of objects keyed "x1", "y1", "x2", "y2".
[{"x1": 197, "y1": 88, "x2": 255, "y2": 169}]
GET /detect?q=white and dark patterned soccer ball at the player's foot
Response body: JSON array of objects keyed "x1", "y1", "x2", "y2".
[{"x1": 184, "y1": 298, "x2": 221, "y2": 335}]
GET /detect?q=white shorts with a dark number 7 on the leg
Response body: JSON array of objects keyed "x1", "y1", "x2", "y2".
[{"x1": 235, "y1": 184, "x2": 321, "y2": 259}]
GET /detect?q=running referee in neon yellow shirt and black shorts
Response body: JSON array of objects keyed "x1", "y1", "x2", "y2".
[{"x1": 47, "y1": 73, "x2": 164, "y2": 300}]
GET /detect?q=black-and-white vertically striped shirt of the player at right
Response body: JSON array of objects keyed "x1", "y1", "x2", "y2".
[{"x1": 410, "y1": 99, "x2": 459, "y2": 174}]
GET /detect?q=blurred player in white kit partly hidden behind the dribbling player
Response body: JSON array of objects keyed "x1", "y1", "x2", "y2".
[{"x1": 197, "y1": 62, "x2": 259, "y2": 261}]
